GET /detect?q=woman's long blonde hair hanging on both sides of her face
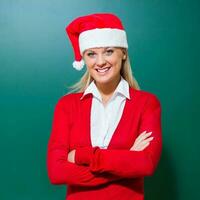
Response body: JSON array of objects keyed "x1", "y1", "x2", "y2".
[{"x1": 68, "y1": 49, "x2": 140, "y2": 93}]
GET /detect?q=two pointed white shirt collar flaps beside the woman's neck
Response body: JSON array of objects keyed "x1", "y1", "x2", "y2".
[{"x1": 80, "y1": 76, "x2": 130, "y2": 100}]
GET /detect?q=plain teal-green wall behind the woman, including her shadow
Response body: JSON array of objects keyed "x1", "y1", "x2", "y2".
[{"x1": 0, "y1": 0, "x2": 200, "y2": 200}]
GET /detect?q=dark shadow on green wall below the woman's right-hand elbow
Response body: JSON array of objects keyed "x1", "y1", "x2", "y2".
[{"x1": 145, "y1": 146, "x2": 178, "y2": 200}]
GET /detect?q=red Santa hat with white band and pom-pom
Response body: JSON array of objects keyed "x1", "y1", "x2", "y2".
[{"x1": 66, "y1": 13, "x2": 128, "y2": 70}]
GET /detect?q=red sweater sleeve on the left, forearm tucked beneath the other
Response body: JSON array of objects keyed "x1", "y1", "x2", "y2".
[{"x1": 47, "y1": 96, "x2": 121, "y2": 186}]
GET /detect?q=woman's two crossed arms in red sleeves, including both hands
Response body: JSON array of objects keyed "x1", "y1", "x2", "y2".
[{"x1": 47, "y1": 94, "x2": 161, "y2": 186}]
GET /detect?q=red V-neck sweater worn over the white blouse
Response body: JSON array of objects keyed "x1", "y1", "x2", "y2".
[{"x1": 47, "y1": 87, "x2": 162, "y2": 200}]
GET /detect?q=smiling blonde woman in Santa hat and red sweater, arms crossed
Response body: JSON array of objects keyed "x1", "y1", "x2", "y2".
[{"x1": 47, "y1": 13, "x2": 162, "y2": 200}]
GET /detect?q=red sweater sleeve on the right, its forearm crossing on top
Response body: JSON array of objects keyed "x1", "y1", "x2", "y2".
[{"x1": 75, "y1": 95, "x2": 162, "y2": 178}]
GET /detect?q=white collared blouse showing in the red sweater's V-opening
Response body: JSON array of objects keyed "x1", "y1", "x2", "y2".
[{"x1": 81, "y1": 76, "x2": 130, "y2": 148}]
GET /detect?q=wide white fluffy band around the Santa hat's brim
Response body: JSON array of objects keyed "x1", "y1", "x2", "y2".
[{"x1": 79, "y1": 28, "x2": 128, "y2": 55}]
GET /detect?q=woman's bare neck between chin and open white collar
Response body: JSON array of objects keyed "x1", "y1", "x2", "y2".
[{"x1": 96, "y1": 76, "x2": 121, "y2": 96}]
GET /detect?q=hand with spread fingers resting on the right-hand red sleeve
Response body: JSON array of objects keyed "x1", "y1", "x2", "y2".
[{"x1": 130, "y1": 131, "x2": 153, "y2": 151}]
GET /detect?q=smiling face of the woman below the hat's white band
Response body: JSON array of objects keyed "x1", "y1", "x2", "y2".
[{"x1": 83, "y1": 47, "x2": 126, "y2": 84}]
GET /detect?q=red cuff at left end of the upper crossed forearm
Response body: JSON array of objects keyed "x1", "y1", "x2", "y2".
[{"x1": 75, "y1": 147, "x2": 99, "y2": 165}]
